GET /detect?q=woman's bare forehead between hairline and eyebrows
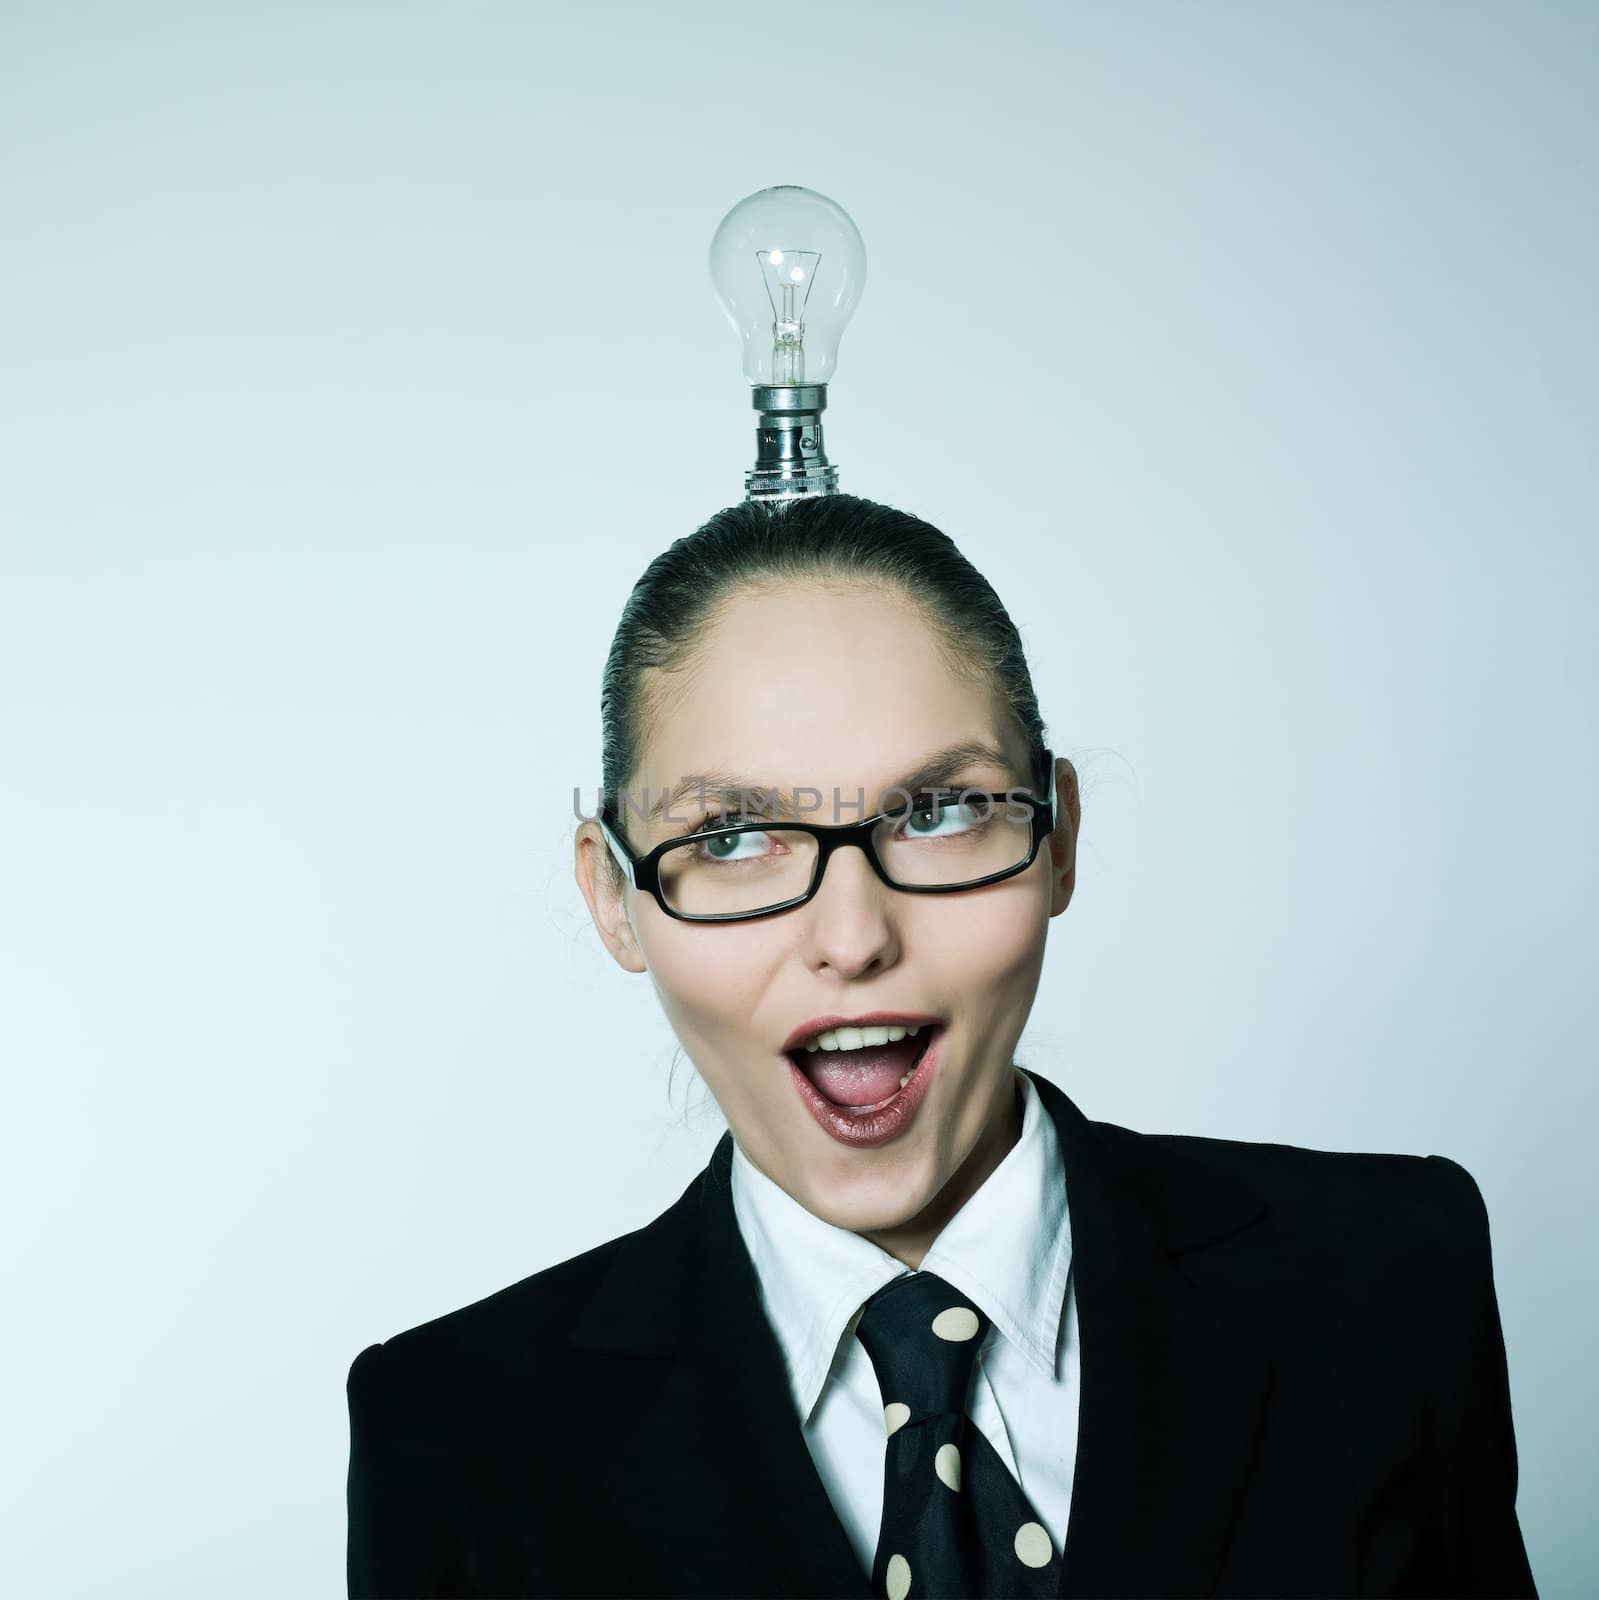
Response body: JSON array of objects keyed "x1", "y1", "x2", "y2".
[{"x1": 640, "y1": 582, "x2": 1010, "y2": 784}]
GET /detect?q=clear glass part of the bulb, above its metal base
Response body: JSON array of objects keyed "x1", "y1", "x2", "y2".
[{"x1": 711, "y1": 184, "x2": 866, "y2": 389}]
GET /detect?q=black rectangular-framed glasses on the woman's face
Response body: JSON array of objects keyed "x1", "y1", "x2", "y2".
[{"x1": 597, "y1": 750, "x2": 1055, "y2": 922}]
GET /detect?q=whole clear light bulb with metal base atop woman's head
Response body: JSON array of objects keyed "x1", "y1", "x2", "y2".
[{"x1": 711, "y1": 184, "x2": 866, "y2": 499}]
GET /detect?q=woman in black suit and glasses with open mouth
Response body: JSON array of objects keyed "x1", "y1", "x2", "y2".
[{"x1": 349, "y1": 494, "x2": 1533, "y2": 1600}]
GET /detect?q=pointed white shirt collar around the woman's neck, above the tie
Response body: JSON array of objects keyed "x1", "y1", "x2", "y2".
[{"x1": 731, "y1": 1067, "x2": 1071, "y2": 1422}]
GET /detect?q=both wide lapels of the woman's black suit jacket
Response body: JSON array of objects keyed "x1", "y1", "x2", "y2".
[{"x1": 571, "y1": 1072, "x2": 1269, "y2": 1600}]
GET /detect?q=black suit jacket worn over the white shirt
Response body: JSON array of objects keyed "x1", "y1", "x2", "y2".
[{"x1": 347, "y1": 1072, "x2": 1535, "y2": 1597}]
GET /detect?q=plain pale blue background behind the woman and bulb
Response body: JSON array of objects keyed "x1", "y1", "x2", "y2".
[{"x1": 0, "y1": 0, "x2": 1599, "y2": 1597}]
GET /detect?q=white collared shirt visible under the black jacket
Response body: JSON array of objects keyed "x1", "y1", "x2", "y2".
[{"x1": 731, "y1": 1069, "x2": 1080, "y2": 1573}]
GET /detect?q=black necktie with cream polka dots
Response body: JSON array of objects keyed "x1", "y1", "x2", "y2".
[{"x1": 855, "y1": 1272, "x2": 1061, "y2": 1600}]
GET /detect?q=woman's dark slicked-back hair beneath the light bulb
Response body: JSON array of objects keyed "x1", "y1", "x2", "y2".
[{"x1": 600, "y1": 494, "x2": 1052, "y2": 889}]
